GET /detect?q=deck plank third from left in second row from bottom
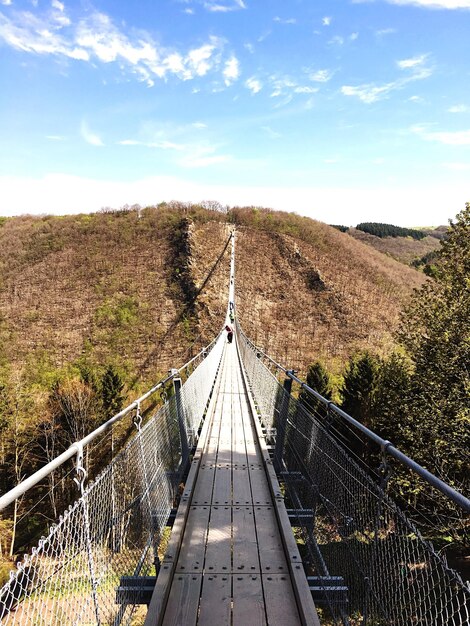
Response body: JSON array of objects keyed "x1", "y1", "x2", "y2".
[{"x1": 232, "y1": 506, "x2": 260, "y2": 574}]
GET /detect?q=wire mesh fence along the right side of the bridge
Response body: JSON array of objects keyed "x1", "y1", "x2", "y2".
[{"x1": 239, "y1": 326, "x2": 470, "y2": 626}]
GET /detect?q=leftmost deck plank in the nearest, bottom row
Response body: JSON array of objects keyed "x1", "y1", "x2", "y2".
[{"x1": 162, "y1": 574, "x2": 202, "y2": 626}]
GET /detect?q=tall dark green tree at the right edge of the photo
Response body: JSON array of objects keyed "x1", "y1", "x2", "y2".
[{"x1": 400, "y1": 204, "x2": 470, "y2": 489}]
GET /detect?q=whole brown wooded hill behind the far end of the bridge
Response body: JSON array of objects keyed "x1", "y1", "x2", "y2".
[{"x1": 0, "y1": 203, "x2": 424, "y2": 380}]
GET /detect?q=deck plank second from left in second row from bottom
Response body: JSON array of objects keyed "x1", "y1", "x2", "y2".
[{"x1": 204, "y1": 506, "x2": 232, "y2": 574}]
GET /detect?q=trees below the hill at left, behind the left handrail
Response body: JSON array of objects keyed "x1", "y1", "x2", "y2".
[{"x1": 0, "y1": 362, "x2": 127, "y2": 585}]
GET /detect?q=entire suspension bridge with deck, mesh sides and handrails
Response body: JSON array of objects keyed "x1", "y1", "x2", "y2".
[{"x1": 0, "y1": 234, "x2": 470, "y2": 626}]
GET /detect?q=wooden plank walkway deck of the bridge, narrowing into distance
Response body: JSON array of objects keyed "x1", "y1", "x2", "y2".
[{"x1": 145, "y1": 343, "x2": 319, "y2": 626}]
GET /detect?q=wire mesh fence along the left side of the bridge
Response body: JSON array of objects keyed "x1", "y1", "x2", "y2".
[{"x1": 0, "y1": 337, "x2": 224, "y2": 626}]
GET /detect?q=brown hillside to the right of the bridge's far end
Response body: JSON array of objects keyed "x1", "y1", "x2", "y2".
[{"x1": 229, "y1": 209, "x2": 424, "y2": 374}]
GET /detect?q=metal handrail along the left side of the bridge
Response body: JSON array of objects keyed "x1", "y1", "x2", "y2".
[{"x1": 0, "y1": 333, "x2": 220, "y2": 511}]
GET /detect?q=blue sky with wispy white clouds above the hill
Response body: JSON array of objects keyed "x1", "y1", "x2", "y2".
[{"x1": 0, "y1": 0, "x2": 470, "y2": 226}]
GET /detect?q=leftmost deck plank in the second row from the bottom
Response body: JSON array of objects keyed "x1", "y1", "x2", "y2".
[{"x1": 176, "y1": 506, "x2": 210, "y2": 573}]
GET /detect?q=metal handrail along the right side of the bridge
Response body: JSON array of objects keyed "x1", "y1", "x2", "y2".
[{"x1": 237, "y1": 324, "x2": 470, "y2": 512}]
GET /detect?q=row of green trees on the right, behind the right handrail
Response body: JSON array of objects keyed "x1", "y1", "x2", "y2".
[{"x1": 304, "y1": 203, "x2": 470, "y2": 545}]
